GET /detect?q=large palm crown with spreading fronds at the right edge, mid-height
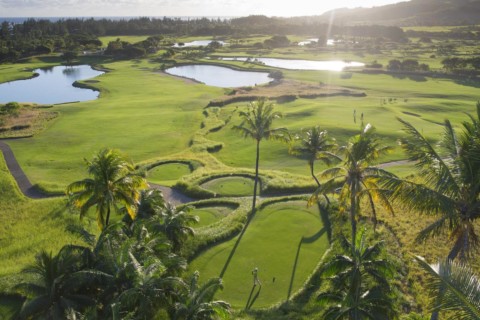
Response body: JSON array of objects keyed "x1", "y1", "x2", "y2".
[{"x1": 387, "y1": 103, "x2": 480, "y2": 261}]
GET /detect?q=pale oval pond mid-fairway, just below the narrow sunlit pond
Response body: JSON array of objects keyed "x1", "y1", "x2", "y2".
[{"x1": 165, "y1": 64, "x2": 273, "y2": 88}]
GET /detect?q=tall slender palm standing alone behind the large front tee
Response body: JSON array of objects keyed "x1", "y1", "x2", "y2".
[{"x1": 233, "y1": 100, "x2": 290, "y2": 216}]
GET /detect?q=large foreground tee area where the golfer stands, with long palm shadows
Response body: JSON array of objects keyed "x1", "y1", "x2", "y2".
[{"x1": 190, "y1": 201, "x2": 329, "y2": 308}]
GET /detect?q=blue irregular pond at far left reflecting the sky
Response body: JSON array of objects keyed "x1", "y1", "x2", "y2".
[{"x1": 0, "y1": 65, "x2": 104, "y2": 104}]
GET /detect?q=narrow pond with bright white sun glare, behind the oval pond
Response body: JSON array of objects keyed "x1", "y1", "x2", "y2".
[{"x1": 220, "y1": 57, "x2": 365, "y2": 71}]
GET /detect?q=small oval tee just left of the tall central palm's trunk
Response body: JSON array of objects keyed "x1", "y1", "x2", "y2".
[{"x1": 201, "y1": 177, "x2": 254, "y2": 197}]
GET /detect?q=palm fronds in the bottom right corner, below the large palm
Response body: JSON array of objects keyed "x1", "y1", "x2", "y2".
[{"x1": 415, "y1": 256, "x2": 480, "y2": 320}]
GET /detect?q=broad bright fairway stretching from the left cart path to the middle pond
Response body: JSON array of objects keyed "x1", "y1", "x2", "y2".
[{"x1": 5, "y1": 61, "x2": 223, "y2": 187}]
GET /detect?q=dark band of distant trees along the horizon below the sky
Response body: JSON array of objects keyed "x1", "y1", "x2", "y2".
[{"x1": 0, "y1": 16, "x2": 406, "y2": 63}]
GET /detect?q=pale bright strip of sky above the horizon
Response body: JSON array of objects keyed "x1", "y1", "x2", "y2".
[{"x1": 0, "y1": 0, "x2": 406, "y2": 17}]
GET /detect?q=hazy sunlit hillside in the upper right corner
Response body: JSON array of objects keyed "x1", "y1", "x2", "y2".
[{"x1": 320, "y1": 0, "x2": 480, "y2": 26}]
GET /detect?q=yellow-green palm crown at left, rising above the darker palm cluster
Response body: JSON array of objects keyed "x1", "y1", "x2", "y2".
[{"x1": 67, "y1": 149, "x2": 147, "y2": 230}]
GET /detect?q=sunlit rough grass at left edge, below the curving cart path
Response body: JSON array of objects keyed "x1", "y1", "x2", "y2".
[{"x1": 0, "y1": 157, "x2": 96, "y2": 291}]
